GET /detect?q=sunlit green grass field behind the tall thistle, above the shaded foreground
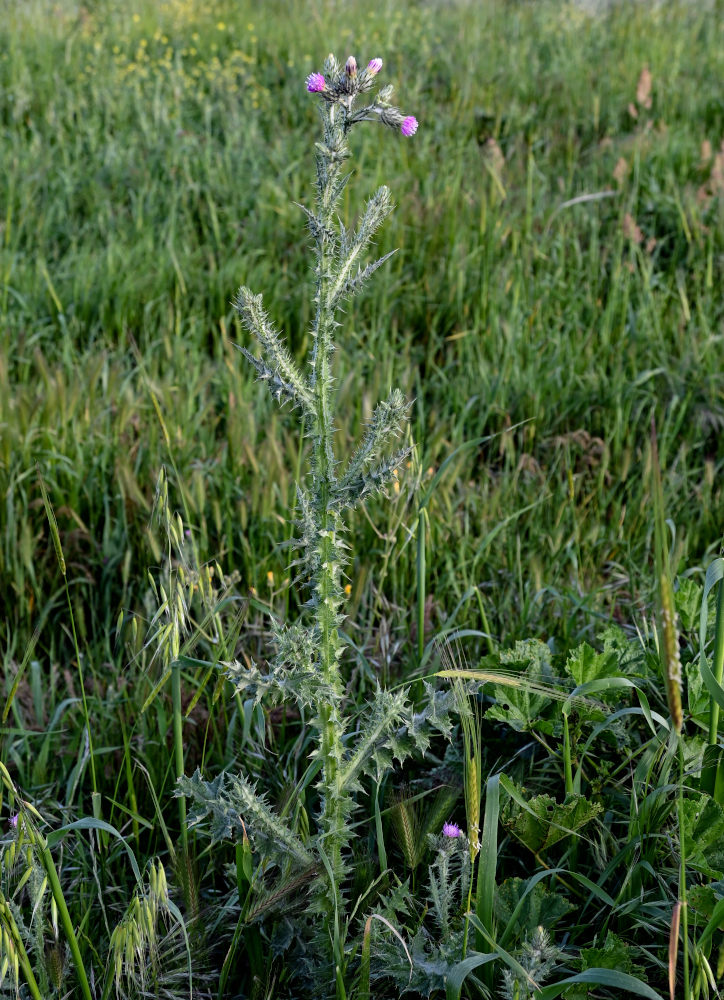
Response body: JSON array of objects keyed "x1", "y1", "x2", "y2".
[{"x1": 0, "y1": 3, "x2": 724, "y2": 656}]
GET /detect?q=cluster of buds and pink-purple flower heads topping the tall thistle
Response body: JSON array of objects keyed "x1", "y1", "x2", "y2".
[{"x1": 306, "y1": 55, "x2": 417, "y2": 136}]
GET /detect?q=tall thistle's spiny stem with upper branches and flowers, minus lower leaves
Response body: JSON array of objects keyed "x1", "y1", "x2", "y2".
[{"x1": 236, "y1": 50, "x2": 417, "y2": 932}]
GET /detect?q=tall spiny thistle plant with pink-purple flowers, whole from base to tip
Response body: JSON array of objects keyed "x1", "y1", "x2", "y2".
[{"x1": 181, "y1": 55, "x2": 449, "y2": 996}]
